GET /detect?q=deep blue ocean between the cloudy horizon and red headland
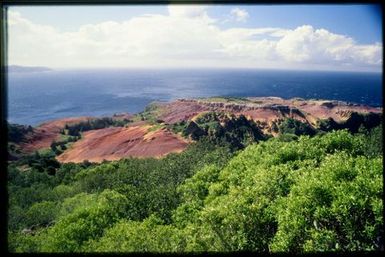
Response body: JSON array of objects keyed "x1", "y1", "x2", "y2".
[{"x1": 8, "y1": 69, "x2": 382, "y2": 125}]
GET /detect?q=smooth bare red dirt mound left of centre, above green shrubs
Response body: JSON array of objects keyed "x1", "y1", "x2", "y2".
[{"x1": 57, "y1": 125, "x2": 188, "y2": 163}]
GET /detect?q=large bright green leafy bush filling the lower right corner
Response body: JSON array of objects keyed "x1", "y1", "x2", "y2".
[{"x1": 174, "y1": 131, "x2": 383, "y2": 252}]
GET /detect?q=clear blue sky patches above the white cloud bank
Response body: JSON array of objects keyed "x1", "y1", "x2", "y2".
[{"x1": 12, "y1": 4, "x2": 382, "y2": 43}]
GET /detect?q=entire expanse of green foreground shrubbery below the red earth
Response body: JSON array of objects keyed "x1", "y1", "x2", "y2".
[{"x1": 8, "y1": 127, "x2": 383, "y2": 252}]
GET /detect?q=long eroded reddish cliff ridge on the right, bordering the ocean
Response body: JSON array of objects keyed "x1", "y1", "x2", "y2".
[{"x1": 152, "y1": 97, "x2": 382, "y2": 126}]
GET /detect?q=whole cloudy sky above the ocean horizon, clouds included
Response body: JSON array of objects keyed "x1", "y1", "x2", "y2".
[{"x1": 7, "y1": 5, "x2": 383, "y2": 72}]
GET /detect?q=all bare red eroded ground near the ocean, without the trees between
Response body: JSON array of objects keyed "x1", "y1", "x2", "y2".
[{"x1": 12, "y1": 97, "x2": 382, "y2": 162}]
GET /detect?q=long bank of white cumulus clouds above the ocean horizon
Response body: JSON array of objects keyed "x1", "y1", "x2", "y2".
[{"x1": 8, "y1": 5, "x2": 383, "y2": 70}]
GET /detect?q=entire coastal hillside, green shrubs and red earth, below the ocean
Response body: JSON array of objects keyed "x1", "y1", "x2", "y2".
[{"x1": 7, "y1": 97, "x2": 384, "y2": 253}]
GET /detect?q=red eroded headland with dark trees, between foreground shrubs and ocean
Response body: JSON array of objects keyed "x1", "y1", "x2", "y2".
[{"x1": 10, "y1": 97, "x2": 382, "y2": 163}]
